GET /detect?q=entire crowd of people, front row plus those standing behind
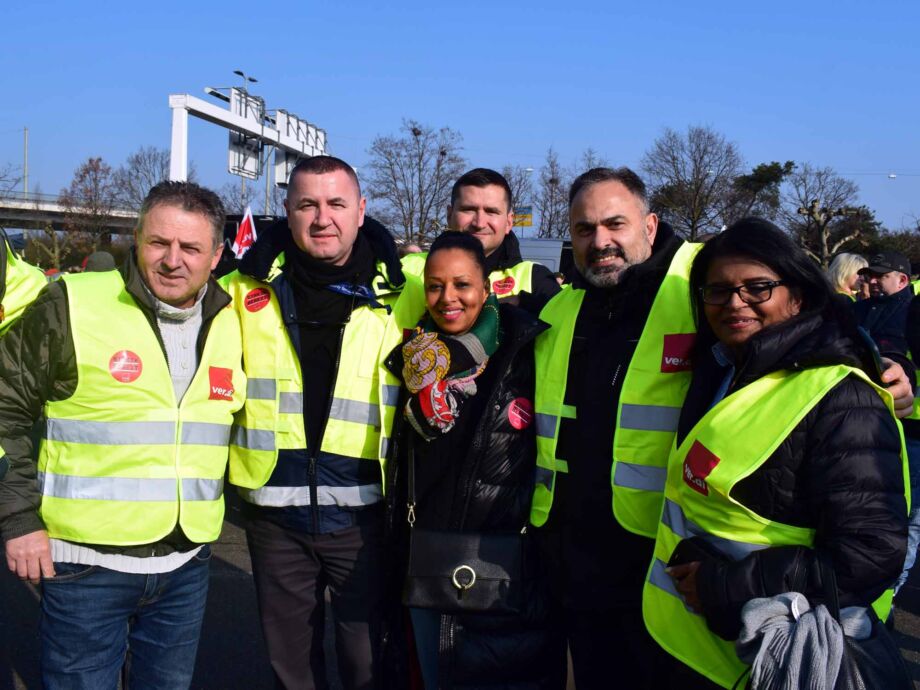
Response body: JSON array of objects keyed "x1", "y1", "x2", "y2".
[{"x1": 0, "y1": 156, "x2": 920, "y2": 690}]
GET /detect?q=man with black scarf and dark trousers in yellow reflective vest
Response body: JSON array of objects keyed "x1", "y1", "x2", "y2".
[{"x1": 224, "y1": 156, "x2": 404, "y2": 689}]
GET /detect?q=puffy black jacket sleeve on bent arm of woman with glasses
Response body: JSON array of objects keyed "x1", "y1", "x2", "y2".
[{"x1": 697, "y1": 377, "x2": 907, "y2": 639}]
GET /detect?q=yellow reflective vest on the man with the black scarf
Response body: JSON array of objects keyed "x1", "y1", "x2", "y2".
[{"x1": 222, "y1": 259, "x2": 399, "y2": 507}]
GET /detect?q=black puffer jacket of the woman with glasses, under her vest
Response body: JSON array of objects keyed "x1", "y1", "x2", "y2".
[{"x1": 677, "y1": 314, "x2": 907, "y2": 639}]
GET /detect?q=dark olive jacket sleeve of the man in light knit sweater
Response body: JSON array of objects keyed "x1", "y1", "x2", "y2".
[{"x1": 0, "y1": 282, "x2": 77, "y2": 540}]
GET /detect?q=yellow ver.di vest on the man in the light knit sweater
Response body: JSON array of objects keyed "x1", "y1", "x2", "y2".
[{"x1": 38, "y1": 271, "x2": 246, "y2": 546}]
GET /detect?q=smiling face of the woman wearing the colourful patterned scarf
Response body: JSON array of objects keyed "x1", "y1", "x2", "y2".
[{"x1": 425, "y1": 249, "x2": 489, "y2": 335}]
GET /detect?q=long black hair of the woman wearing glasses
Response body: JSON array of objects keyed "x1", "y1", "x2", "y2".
[{"x1": 690, "y1": 218, "x2": 836, "y2": 332}]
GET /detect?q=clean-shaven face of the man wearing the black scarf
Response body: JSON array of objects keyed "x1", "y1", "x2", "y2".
[{"x1": 284, "y1": 170, "x2": 366, "y2": 266}]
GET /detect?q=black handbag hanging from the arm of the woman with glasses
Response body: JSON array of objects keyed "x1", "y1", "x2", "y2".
[{"x1": 818, "y1": 553, "x2": 914, "y2": 690}]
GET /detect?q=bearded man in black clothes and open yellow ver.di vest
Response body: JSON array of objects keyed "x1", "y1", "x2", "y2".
[{"x1": 531, "y1": 168, "x2": 910, "y2": 690}]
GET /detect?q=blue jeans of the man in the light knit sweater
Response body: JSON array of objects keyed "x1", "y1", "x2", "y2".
[{"x1": 39, "y1": 546, "x2": 211, "y2": 690}]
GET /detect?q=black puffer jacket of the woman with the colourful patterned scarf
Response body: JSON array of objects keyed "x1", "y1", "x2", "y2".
[{"x1": 386, "y1": 304, "x2": 564, "y2": 688}]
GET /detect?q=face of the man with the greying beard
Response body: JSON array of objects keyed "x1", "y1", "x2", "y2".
[{"x1": 569, "y1": 180, "x2": 658, "y2": 287}]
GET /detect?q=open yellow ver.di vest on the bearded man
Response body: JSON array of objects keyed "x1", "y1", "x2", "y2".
[{"x1": 530, "y1": 242, "x2": 702, "y2": 537}]
